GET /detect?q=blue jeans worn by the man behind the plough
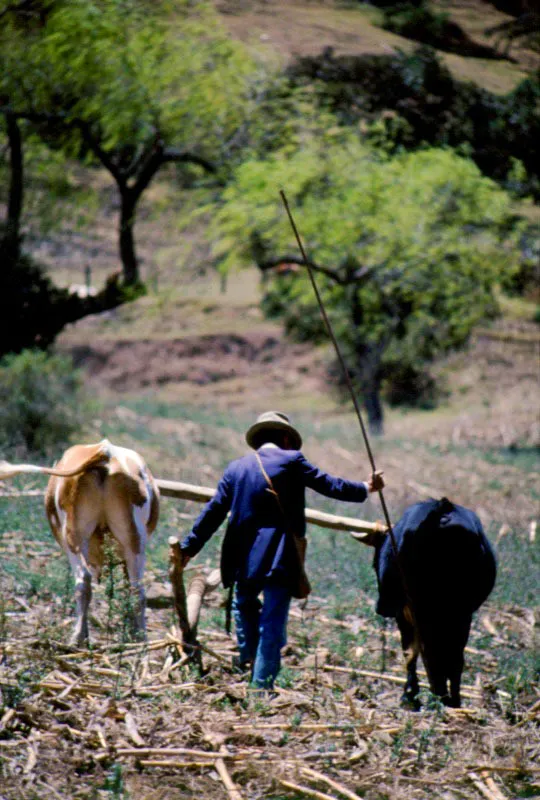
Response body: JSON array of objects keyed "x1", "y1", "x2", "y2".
[{"x1": 233, "y1": 584, "x2": 291, "y2": 689}]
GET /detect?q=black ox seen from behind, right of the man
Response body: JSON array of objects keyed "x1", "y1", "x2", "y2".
[{"x1": 374, "y1": 498, "x2": 497, "y2": 709}]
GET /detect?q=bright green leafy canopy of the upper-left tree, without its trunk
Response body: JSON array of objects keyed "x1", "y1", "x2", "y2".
[{"x1": 0, "y1": 0, "x2": 253, "y2": 161}]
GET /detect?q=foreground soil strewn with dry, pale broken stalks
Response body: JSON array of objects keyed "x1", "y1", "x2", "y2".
[{"x1": 0, "y1": 580, "x2": 539, "y2": 800}]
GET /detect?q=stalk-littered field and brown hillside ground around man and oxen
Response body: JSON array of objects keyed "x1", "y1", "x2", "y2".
[{"x1": 0, "y1": 0, "x2": 540, "y2": 800}]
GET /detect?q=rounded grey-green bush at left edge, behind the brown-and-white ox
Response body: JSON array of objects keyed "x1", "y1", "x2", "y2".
[{"x1": 0, "y1": 350, "x2": 85, "y2": 455}]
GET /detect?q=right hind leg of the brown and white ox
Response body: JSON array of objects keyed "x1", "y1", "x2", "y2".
[{"x1": 106, "y1": 475, "x2": 148, "y2": 638}]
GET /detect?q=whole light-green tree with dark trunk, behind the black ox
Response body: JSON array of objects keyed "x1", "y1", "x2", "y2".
[{"x1": 209, "y1": 133, "x2": 514, "y2": 432}]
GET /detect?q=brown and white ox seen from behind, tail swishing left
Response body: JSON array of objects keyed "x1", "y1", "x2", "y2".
[{"x1": 0, "y1": 439, "x2": 159, "y2": 645}]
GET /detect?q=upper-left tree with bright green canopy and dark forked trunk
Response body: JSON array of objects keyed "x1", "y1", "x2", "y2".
[{"x1": 0, "y1": 0, "x2": 255, "y2": 285}]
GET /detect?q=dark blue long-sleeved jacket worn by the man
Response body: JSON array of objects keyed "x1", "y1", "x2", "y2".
[{"x1": 181, "y1": 445, "x2": 367, "y2": 587}]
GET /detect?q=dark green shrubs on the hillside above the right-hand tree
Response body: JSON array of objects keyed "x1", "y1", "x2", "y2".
[{"x1": 288, "y1": 43, "x2": 540, "y2": 197}]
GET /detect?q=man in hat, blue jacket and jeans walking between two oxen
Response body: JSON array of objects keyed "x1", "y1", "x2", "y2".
[{"x1": 181, "y1": 411, "x2": 384, "y2": 689}]
